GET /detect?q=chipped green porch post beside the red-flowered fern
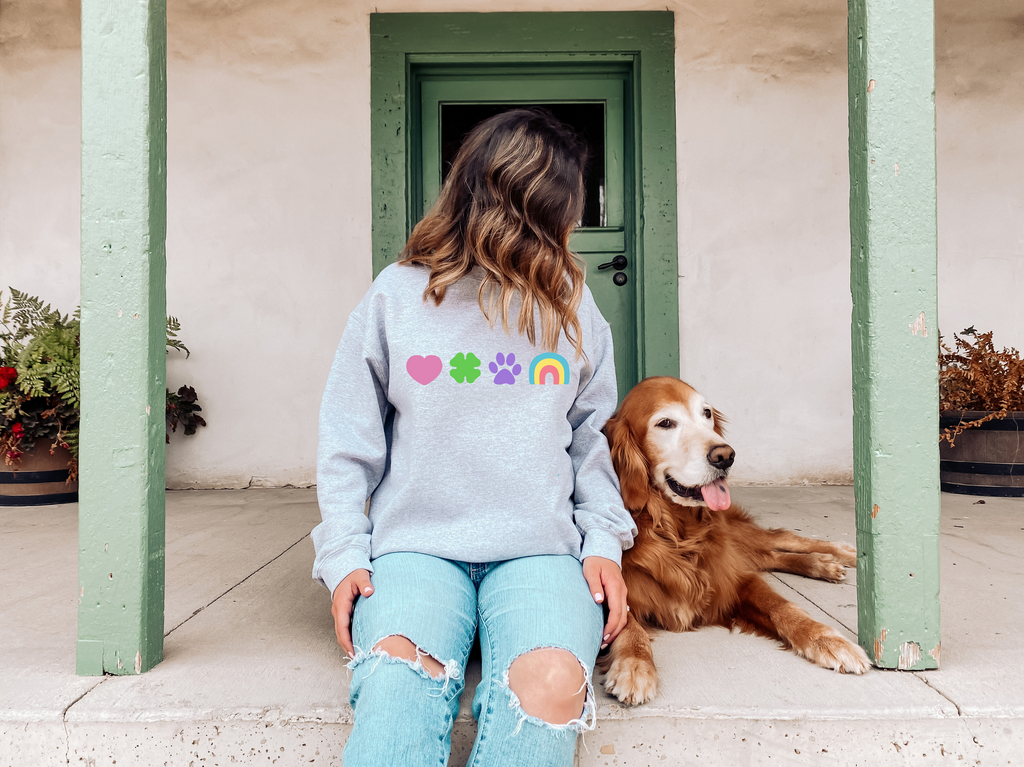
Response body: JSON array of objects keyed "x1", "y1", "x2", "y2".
[{"x1": 77, "y1": 0, "x2": 167, "y2": 676}]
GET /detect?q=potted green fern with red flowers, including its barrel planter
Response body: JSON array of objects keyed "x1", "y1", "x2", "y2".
[{"x1": 0, "y1": 288, "x2": 206, "y2": 506}]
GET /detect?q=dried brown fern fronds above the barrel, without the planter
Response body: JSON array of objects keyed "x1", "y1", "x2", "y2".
[{"x1": 939, "y1": 326, "x2": 1024, "y2": 445}]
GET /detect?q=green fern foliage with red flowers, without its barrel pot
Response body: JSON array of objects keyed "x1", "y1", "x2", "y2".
[{"x1": 0, "y1": 288, "x2": 206, "y2": 469}]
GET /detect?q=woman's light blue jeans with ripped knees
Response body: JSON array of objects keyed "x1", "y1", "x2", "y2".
[{"x1": 344, "y1": 552, "x2": 603, "y2": 767}]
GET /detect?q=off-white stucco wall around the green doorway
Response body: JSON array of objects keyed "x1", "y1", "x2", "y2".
[{"x1": 0, "y1": 0, "x2": 1024, "y2": 486}]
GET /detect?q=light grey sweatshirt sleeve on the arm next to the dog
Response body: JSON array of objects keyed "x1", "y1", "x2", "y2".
[{"x1": 568, "y1": 307, "x2": 637, "y2": 564}]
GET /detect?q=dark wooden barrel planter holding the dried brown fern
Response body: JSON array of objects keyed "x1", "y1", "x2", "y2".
[{"x1": 939, "y1": 411, "x2": 1024, "y2": 498}]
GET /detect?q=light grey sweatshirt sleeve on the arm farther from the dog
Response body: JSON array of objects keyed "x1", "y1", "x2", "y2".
[{"x1": 312, "y1": 306, "x2": 391, "y2": 595}]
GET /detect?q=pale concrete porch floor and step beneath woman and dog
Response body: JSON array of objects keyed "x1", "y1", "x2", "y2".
[{"x1": 0, "y1": 486, "x2": 1024, "y2": 767}]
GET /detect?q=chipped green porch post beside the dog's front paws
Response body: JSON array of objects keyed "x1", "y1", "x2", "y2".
[{"x1": 849, "y1": 0, "x2": 940, "y2": 670}]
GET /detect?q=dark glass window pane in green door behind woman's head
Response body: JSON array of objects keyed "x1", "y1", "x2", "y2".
[{"x1": 440, "y1": 102, "x2": 607, "y2": 226}]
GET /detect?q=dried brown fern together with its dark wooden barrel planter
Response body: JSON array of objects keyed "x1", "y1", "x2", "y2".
[{"x1": 939, "y1": 326, "x2": 1024, "y2": 497}]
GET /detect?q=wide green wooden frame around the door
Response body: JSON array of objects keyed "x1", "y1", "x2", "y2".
[{"x1": 370, "y1": 11, "x2": 679, "y2": 378}]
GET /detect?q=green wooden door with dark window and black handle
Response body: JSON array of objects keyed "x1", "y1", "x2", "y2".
[{"x1": 410, "y1": 69, "x2": 638, "y2": 398}]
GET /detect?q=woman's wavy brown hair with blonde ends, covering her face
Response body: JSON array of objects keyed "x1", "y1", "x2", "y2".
[{"x1": 400, "y1": 108, "x2": 587, "y2": 357}]
